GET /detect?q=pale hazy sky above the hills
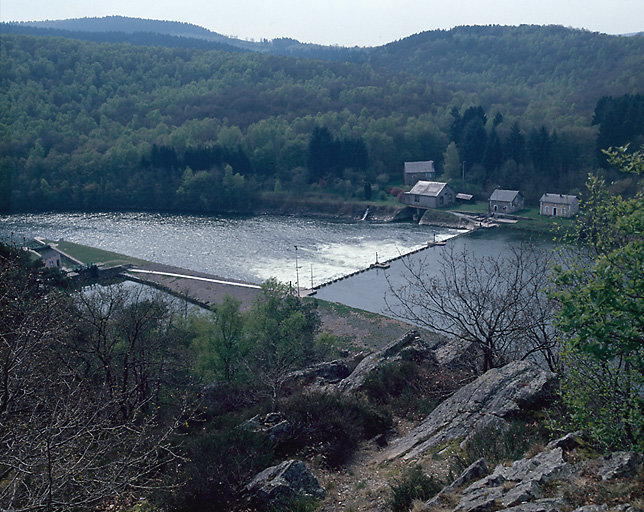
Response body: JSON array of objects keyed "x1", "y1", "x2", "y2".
[{"x1": 0, "y1": 0, "x2": 644, "y2": 46}]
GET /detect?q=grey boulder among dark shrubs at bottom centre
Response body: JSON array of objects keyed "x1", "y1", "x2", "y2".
[{"x1": 243, "y1": 460, "x2": 325, "y2": 510}]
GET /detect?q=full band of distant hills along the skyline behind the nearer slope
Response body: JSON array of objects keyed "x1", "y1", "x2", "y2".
[{"x1": 6, "y1": 16, "x2": 644, "y2": 123}]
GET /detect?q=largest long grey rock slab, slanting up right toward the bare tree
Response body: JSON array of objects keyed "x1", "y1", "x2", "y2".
[{"x1": 380, "y1": 361, "x2": 556, "y2": 460}]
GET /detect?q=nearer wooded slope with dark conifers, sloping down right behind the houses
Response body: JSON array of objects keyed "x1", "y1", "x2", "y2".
[{"x1": 0, "y1": 31, "x2": 641, "y2": 212}]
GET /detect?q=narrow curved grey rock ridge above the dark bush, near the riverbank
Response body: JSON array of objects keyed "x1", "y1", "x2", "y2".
[{"x1": 337, "y1": 331, "x2": 436, "y2": 393}]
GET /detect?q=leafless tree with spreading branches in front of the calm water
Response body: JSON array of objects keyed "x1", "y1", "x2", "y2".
[{"x1": 387, "y1": 244, "x2": 557, "y2": 371}]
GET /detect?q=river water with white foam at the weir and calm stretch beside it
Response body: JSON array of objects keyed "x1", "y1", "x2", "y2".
[{"x1": 0, "y1": 212, "x2": 552, "y2": 313}]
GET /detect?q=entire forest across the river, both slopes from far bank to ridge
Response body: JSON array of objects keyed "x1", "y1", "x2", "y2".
[{"x1": 0, "y1": 26, "x2": 644, "y2": 212}]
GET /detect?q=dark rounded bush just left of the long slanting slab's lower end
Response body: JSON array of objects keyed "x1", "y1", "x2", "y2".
[{"x1": 277, "y1": 392, "x2": 392, "y2": 468}]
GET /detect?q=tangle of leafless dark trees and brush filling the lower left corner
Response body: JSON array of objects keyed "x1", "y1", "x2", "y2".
[{"x1": 0, "y1": 246, "x2": 191, "y2": 511}]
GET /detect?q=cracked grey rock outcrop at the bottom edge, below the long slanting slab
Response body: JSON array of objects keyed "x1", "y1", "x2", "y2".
[{"x1": 454, "y1": 448, "x2": 572, "y2": 512}]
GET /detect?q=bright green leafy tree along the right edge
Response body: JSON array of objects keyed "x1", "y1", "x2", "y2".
[{"x1": 554, "y1": 147, "x2": 644, "y2": 452}]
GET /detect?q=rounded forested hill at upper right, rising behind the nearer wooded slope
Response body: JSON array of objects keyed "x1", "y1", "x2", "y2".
[{"x1": 368, "y1": 25, "x2": 644, "y2": 118}]
